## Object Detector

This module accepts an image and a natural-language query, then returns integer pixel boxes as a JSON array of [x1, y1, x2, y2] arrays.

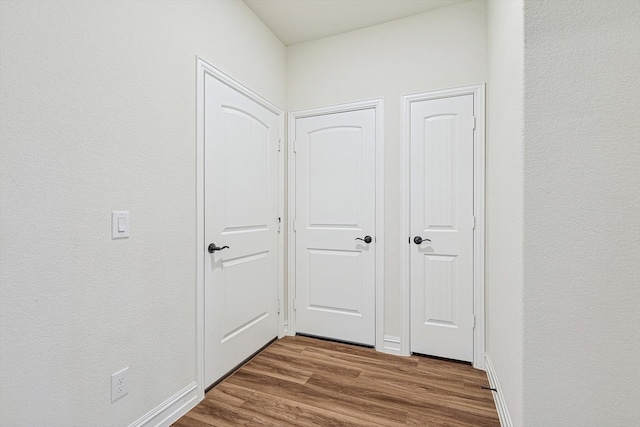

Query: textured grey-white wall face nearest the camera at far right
[[524, 0, 640, 426]]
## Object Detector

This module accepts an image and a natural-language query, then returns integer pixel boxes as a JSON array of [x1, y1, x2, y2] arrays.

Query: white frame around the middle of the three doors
[[287, 98, 384, 351]]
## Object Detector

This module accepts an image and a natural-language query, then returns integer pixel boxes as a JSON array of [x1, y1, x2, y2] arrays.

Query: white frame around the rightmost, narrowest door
[[400, 83, 485, 369]]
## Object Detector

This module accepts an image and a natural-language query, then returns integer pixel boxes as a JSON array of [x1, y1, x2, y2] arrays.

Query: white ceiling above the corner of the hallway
[[244, 0, 468, 46]]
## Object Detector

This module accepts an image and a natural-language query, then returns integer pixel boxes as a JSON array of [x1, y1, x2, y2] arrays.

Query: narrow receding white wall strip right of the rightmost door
[[486, 0, 524, 426]]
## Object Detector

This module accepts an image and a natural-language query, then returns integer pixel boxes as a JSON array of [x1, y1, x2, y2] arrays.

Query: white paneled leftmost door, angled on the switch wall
[[202, 74, 279, 386]]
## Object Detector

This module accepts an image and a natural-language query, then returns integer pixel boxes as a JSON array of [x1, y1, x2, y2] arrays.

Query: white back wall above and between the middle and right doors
[[287, 0, 487, 337]]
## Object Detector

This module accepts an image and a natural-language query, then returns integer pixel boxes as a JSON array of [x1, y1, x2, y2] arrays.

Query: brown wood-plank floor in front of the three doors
[[173, 337, 500, 427]]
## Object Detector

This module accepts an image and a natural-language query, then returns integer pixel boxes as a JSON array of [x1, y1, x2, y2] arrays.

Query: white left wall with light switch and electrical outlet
[[0, 0, 285, 426]]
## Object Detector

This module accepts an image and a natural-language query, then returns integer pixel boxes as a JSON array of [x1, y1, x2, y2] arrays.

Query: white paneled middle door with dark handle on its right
[[294, 108, 376, 345]]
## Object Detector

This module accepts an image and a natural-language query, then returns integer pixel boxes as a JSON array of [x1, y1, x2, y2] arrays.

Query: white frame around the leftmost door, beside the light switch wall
[[196, 57, 284, 400]]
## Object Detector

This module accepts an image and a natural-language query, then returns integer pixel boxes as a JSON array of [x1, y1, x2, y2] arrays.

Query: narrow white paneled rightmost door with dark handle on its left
[[410, 95, 475, 361]]
